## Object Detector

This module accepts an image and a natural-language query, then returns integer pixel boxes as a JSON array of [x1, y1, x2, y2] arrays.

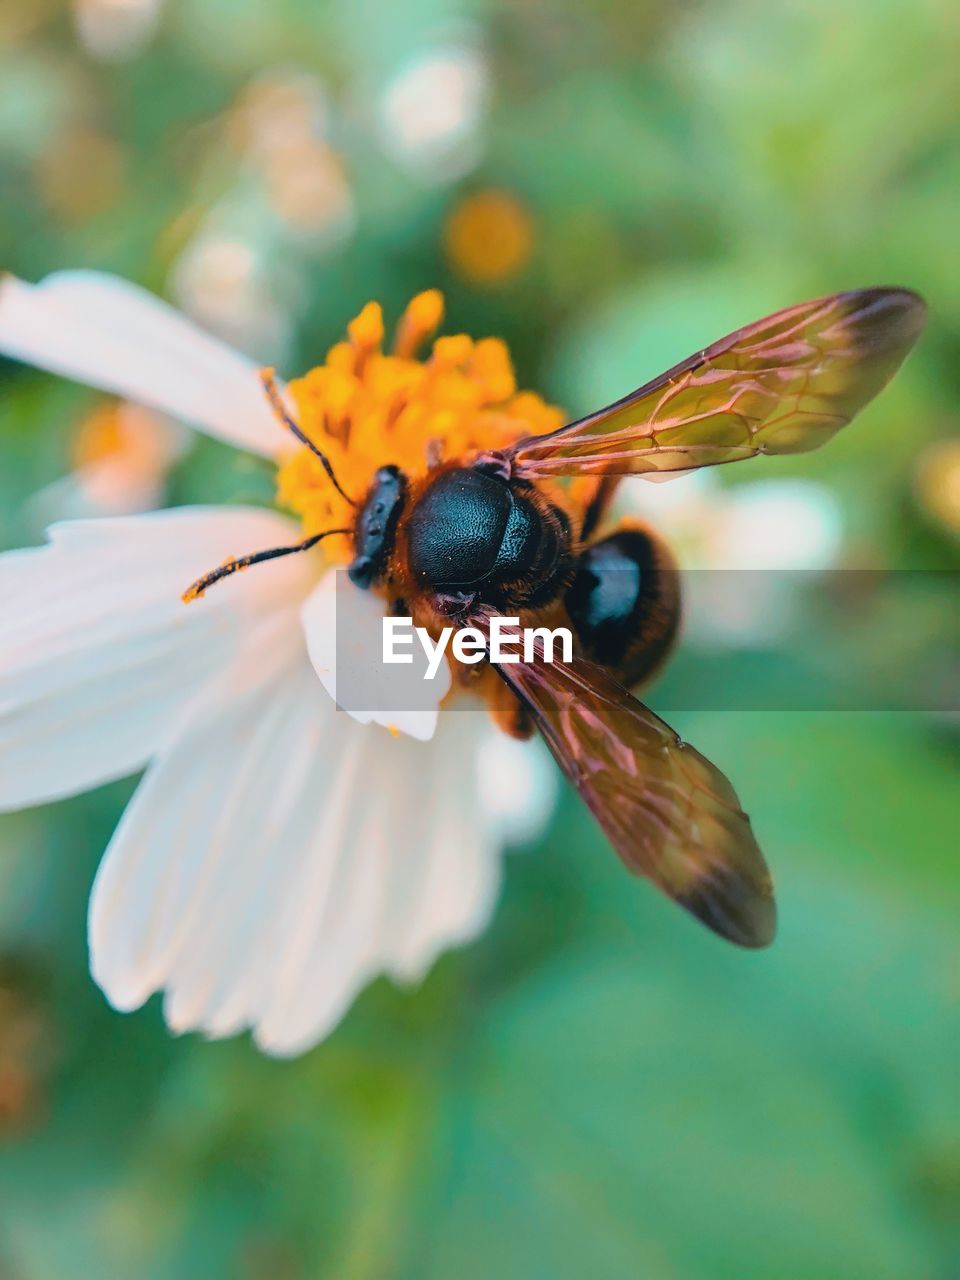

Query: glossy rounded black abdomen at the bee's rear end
[[564, 521, 680, 689]]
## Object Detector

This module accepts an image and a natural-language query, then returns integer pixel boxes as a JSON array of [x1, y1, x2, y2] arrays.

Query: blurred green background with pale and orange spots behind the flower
[[0, 0, 960, 1280]]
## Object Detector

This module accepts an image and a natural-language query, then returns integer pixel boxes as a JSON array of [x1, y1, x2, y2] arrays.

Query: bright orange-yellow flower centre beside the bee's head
[[276, 289, 563, 563]]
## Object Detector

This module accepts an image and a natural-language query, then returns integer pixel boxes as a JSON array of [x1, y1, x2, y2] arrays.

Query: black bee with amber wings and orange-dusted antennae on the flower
[[187, 288, 925, 947]]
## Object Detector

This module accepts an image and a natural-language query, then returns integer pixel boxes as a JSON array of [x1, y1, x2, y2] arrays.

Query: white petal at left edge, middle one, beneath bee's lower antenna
[[0, 507, 314, 809]]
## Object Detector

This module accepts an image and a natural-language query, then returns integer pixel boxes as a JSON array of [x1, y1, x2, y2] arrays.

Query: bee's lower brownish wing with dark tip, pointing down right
[[477, 621, 777, 947]]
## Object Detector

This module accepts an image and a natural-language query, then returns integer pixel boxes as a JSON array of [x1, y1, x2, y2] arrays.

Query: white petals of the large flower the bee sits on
[[0, 271, 553, 1055]]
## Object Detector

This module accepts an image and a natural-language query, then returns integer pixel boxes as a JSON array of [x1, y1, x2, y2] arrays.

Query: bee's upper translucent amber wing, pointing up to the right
[[504, 288, 927, 480]]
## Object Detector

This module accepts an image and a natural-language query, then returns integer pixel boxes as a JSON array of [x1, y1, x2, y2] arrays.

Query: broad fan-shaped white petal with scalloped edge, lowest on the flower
[[90, 660, 499, 1056]]
